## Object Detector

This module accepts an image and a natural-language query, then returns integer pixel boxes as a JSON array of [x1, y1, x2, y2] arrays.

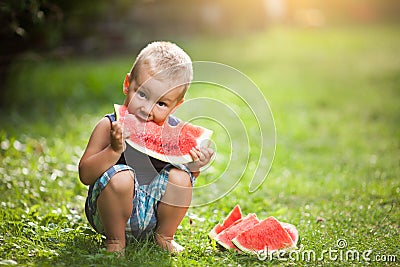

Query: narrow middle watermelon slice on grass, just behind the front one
[[215, 213, 260, 250]]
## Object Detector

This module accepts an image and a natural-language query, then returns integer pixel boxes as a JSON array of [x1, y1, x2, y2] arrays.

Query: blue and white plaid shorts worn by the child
[[85, 164, 195, 239]]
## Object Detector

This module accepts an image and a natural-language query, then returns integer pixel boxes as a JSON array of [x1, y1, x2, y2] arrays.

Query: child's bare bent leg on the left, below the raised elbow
[[97, 171, 135, 252]]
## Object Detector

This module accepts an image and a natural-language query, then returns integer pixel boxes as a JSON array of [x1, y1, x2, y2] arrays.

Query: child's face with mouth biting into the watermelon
[[125, 68, 183, 125]]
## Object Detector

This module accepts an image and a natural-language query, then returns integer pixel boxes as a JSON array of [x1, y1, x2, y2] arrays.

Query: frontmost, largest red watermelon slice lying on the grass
[[232, 216, 296, 253]]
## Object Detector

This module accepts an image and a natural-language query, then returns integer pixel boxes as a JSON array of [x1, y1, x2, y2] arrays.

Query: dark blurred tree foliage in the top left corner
[[0, 0, 136, 105]]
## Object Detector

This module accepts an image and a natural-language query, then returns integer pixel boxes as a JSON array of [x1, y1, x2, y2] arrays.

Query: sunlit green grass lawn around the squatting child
[[0, 26, 400, 266]]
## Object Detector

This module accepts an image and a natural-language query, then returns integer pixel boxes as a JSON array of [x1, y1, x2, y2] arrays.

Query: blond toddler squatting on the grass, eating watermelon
[[79, 42, 214, 253]]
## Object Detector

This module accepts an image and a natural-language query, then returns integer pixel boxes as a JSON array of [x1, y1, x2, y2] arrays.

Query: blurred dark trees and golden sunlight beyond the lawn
[[0, 0, 400, 98]]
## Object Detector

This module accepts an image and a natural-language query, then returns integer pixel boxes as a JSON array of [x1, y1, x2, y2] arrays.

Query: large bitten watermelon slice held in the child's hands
[[114, 104, 213, 164]]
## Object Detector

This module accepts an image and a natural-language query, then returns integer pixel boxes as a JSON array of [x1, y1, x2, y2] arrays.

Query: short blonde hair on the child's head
[[130, 41, 193, 90]]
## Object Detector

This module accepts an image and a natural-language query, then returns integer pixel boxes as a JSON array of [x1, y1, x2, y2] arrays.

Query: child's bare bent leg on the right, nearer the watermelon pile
[[156, 168, 192, 252]]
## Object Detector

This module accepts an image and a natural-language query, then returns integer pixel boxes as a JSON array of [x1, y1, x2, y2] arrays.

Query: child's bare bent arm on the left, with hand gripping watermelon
[[79, 118, 125, 185]]
